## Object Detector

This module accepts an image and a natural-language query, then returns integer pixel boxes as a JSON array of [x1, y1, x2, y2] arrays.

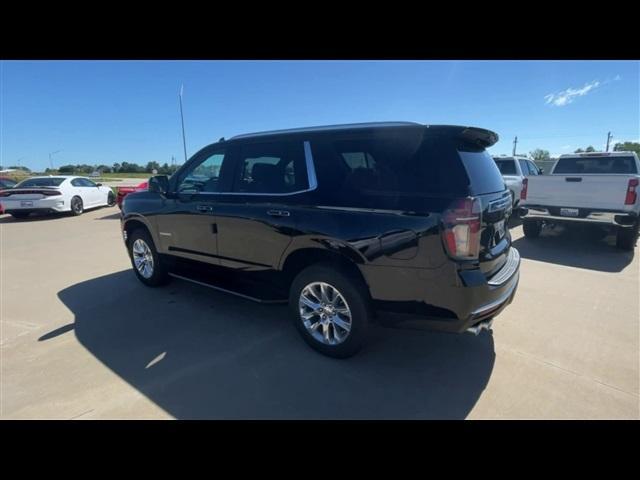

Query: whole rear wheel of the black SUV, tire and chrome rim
[[289, 264, 370, 358]]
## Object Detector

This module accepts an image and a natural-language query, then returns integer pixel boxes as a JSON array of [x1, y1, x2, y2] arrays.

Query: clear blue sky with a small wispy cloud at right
[[0, 61, 640, 171]]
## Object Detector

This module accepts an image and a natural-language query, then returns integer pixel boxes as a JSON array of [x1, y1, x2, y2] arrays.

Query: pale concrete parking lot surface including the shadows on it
[[0, 208, 640, 419]]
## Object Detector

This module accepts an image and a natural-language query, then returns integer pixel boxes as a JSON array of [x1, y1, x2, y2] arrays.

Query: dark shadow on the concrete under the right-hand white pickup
[[513, 226, 634, 272]]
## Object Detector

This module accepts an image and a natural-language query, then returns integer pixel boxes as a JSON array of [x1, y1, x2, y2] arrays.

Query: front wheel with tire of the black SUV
[[128, 228, 170, 287]]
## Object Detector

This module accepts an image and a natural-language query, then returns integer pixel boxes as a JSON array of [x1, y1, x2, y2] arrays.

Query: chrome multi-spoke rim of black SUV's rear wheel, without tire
[[298, 282, 351, 345]]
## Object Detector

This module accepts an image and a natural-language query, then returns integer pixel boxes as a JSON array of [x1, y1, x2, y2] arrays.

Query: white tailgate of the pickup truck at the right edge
[[523, 174, 638, 210]]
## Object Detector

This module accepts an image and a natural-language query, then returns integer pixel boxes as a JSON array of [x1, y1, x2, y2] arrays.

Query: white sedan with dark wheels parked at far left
[[0, 175, 116, 218]]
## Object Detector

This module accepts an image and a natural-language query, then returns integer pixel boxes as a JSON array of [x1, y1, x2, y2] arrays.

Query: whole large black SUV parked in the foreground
[[122, 122, 520, 357]]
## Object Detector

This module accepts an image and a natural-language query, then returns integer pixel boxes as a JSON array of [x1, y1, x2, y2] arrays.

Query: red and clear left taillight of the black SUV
[[442, 198, 482, 260]]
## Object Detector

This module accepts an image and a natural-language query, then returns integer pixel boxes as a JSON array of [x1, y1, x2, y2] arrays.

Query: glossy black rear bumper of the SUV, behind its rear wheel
[[364, 247, 520, 333]]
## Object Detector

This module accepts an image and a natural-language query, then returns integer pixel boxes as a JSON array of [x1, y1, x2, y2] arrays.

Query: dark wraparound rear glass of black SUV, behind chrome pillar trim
[[312, 130, 505, 205]]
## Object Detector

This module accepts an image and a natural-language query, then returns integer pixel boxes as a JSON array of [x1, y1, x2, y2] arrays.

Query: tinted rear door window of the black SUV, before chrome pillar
[[233, 142, 309, 194]]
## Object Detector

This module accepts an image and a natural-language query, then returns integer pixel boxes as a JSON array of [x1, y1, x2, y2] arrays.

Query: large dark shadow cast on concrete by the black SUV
[[56, 270, 495, 419]]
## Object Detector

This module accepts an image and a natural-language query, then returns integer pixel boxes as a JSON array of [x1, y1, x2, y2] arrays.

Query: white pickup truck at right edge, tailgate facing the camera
[[520, 152, 640, 250]]
